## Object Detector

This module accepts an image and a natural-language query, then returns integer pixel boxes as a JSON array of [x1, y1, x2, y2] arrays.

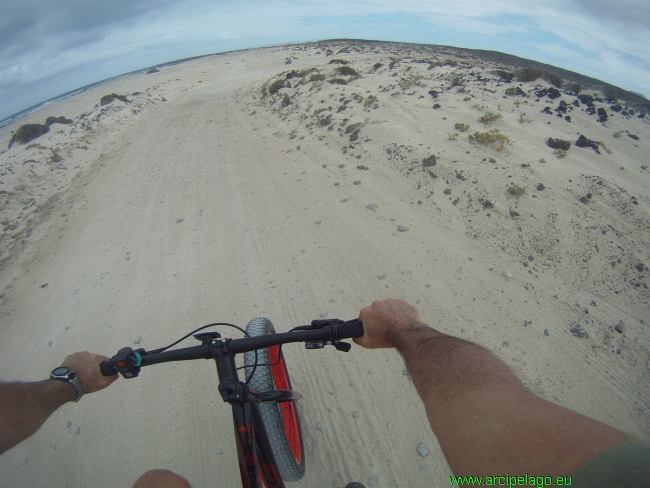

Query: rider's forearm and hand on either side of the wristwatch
[[0, 351, 118, 454]]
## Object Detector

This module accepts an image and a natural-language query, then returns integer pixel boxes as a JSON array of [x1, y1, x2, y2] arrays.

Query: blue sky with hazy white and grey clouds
[[0, 0, 650, 120]]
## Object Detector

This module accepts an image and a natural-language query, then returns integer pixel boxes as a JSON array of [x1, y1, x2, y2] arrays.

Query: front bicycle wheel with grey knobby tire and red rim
[[244, 317, 305, 481]]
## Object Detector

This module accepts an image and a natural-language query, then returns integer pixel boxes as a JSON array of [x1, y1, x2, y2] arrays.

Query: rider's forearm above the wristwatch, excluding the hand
[[0, 380, 77, 454]]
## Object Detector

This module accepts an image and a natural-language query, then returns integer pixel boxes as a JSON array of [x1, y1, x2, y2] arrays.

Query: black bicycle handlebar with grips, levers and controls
[[100, 319, 363, 378]]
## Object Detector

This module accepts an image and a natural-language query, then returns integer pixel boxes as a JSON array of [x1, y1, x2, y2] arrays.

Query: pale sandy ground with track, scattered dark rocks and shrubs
[[0, 43, 650, 487]]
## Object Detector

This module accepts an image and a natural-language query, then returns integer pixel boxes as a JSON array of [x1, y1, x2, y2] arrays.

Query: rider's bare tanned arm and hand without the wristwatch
[[355, 300, 632, 476]]
